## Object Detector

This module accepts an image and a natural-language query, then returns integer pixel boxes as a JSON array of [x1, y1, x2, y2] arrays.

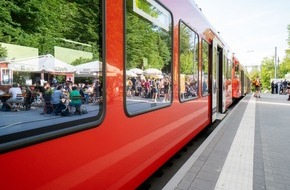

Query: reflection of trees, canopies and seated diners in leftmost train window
[[0, 0, 103, 144]]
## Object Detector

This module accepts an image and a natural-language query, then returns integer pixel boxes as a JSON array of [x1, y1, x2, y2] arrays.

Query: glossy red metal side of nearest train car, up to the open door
[[0, 0, 245, 190]]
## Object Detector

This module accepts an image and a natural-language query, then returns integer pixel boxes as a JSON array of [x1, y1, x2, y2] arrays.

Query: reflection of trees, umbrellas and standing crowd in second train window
[[124, 0, 172, 115]]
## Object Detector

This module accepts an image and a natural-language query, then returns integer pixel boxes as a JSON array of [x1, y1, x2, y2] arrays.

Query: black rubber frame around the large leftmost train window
[[0, 0, 106, 153]]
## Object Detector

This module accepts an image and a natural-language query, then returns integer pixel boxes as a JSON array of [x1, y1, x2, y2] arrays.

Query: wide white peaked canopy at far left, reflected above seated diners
[[8, 54, 76, 73]]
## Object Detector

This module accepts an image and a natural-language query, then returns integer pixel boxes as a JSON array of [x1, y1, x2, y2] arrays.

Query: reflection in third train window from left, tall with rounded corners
[[179, 22, 199, 101]]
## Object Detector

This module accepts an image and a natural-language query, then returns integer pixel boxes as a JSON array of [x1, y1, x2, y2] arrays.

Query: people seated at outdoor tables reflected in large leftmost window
[[2, 78, 102, 115]]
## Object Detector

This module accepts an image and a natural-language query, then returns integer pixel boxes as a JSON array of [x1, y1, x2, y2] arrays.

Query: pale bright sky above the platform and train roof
[[194, 0, 290, 66]]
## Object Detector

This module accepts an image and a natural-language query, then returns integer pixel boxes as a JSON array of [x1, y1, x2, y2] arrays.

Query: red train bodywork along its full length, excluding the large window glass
[[0, 0, 246, 190]]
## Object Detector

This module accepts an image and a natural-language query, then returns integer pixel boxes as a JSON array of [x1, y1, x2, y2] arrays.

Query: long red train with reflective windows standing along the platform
[[0, 0, 248, 190]]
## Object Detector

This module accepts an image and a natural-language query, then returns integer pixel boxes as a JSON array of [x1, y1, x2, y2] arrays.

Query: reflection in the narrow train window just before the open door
[[201, 40, 210, 96]]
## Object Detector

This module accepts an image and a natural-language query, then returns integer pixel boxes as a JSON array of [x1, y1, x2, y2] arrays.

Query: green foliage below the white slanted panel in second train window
[[126, 12, 171, 69]]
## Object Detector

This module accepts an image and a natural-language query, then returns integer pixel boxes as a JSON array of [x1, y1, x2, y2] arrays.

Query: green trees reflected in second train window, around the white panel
[[126, 0, 171, 71]]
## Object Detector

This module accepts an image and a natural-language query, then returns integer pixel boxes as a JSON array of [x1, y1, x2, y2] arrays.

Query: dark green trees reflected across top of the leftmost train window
[[0, 0, 102, 58]]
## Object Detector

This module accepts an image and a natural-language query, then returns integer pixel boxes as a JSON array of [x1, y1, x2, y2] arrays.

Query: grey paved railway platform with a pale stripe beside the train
[[163, 93, 290, 190]]
